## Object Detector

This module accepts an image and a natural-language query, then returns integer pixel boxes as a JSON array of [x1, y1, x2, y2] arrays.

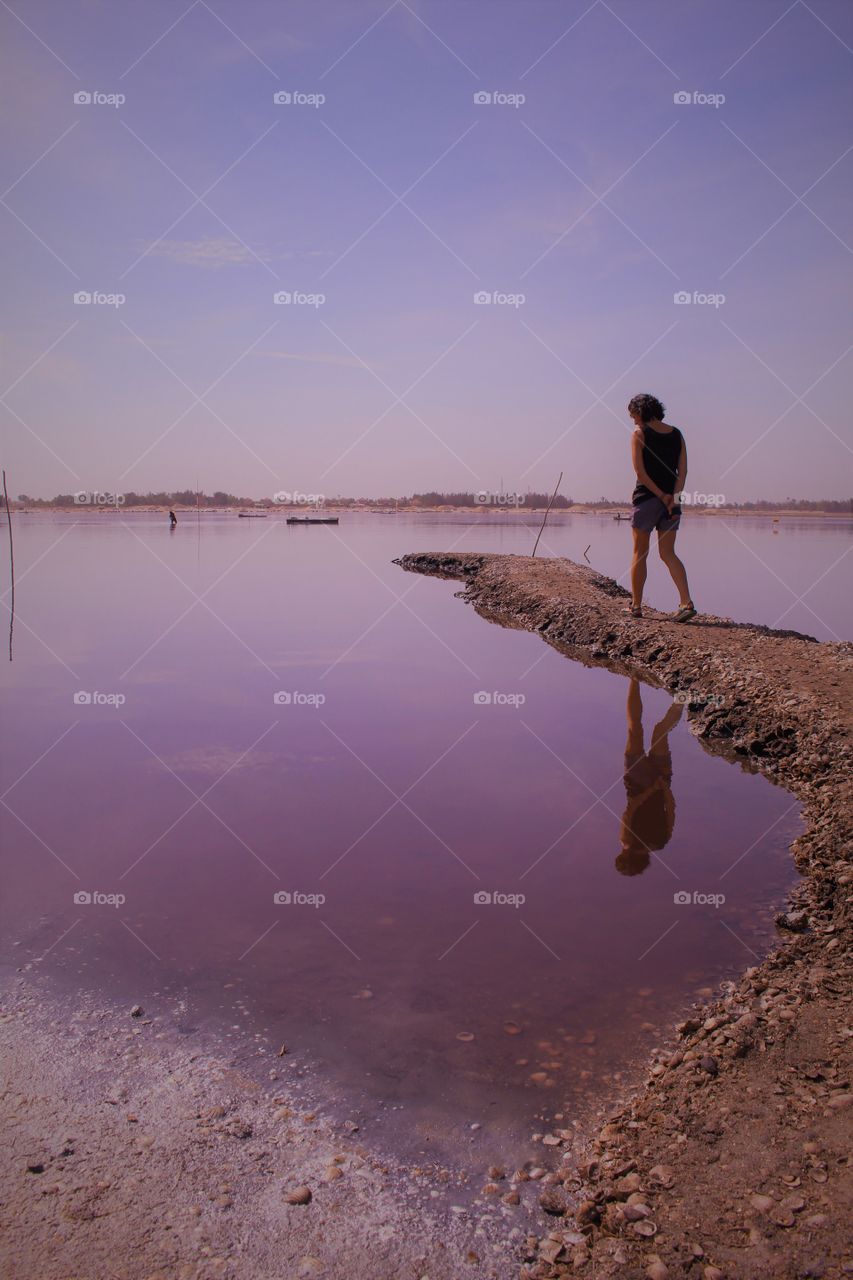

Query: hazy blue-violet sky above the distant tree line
[[0, 0, 853, 502]]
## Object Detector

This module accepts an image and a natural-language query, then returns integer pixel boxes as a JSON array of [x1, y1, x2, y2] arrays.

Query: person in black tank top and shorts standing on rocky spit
[[625, 394, 695, 622]]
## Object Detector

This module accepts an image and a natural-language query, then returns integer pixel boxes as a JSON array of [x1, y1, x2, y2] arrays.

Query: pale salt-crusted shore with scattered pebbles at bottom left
[[0, 975, 543, 1280]]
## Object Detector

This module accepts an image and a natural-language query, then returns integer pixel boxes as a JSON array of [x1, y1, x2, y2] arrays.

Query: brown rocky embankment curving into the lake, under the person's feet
[[397, 553, 853, 1280]]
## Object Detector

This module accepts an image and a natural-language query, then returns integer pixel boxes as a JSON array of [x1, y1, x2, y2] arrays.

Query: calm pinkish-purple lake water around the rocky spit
[[0, 515, 829, 1164]]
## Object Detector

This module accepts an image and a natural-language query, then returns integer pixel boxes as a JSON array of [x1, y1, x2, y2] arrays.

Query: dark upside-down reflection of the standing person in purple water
[[616, 680, 681, 876]]
